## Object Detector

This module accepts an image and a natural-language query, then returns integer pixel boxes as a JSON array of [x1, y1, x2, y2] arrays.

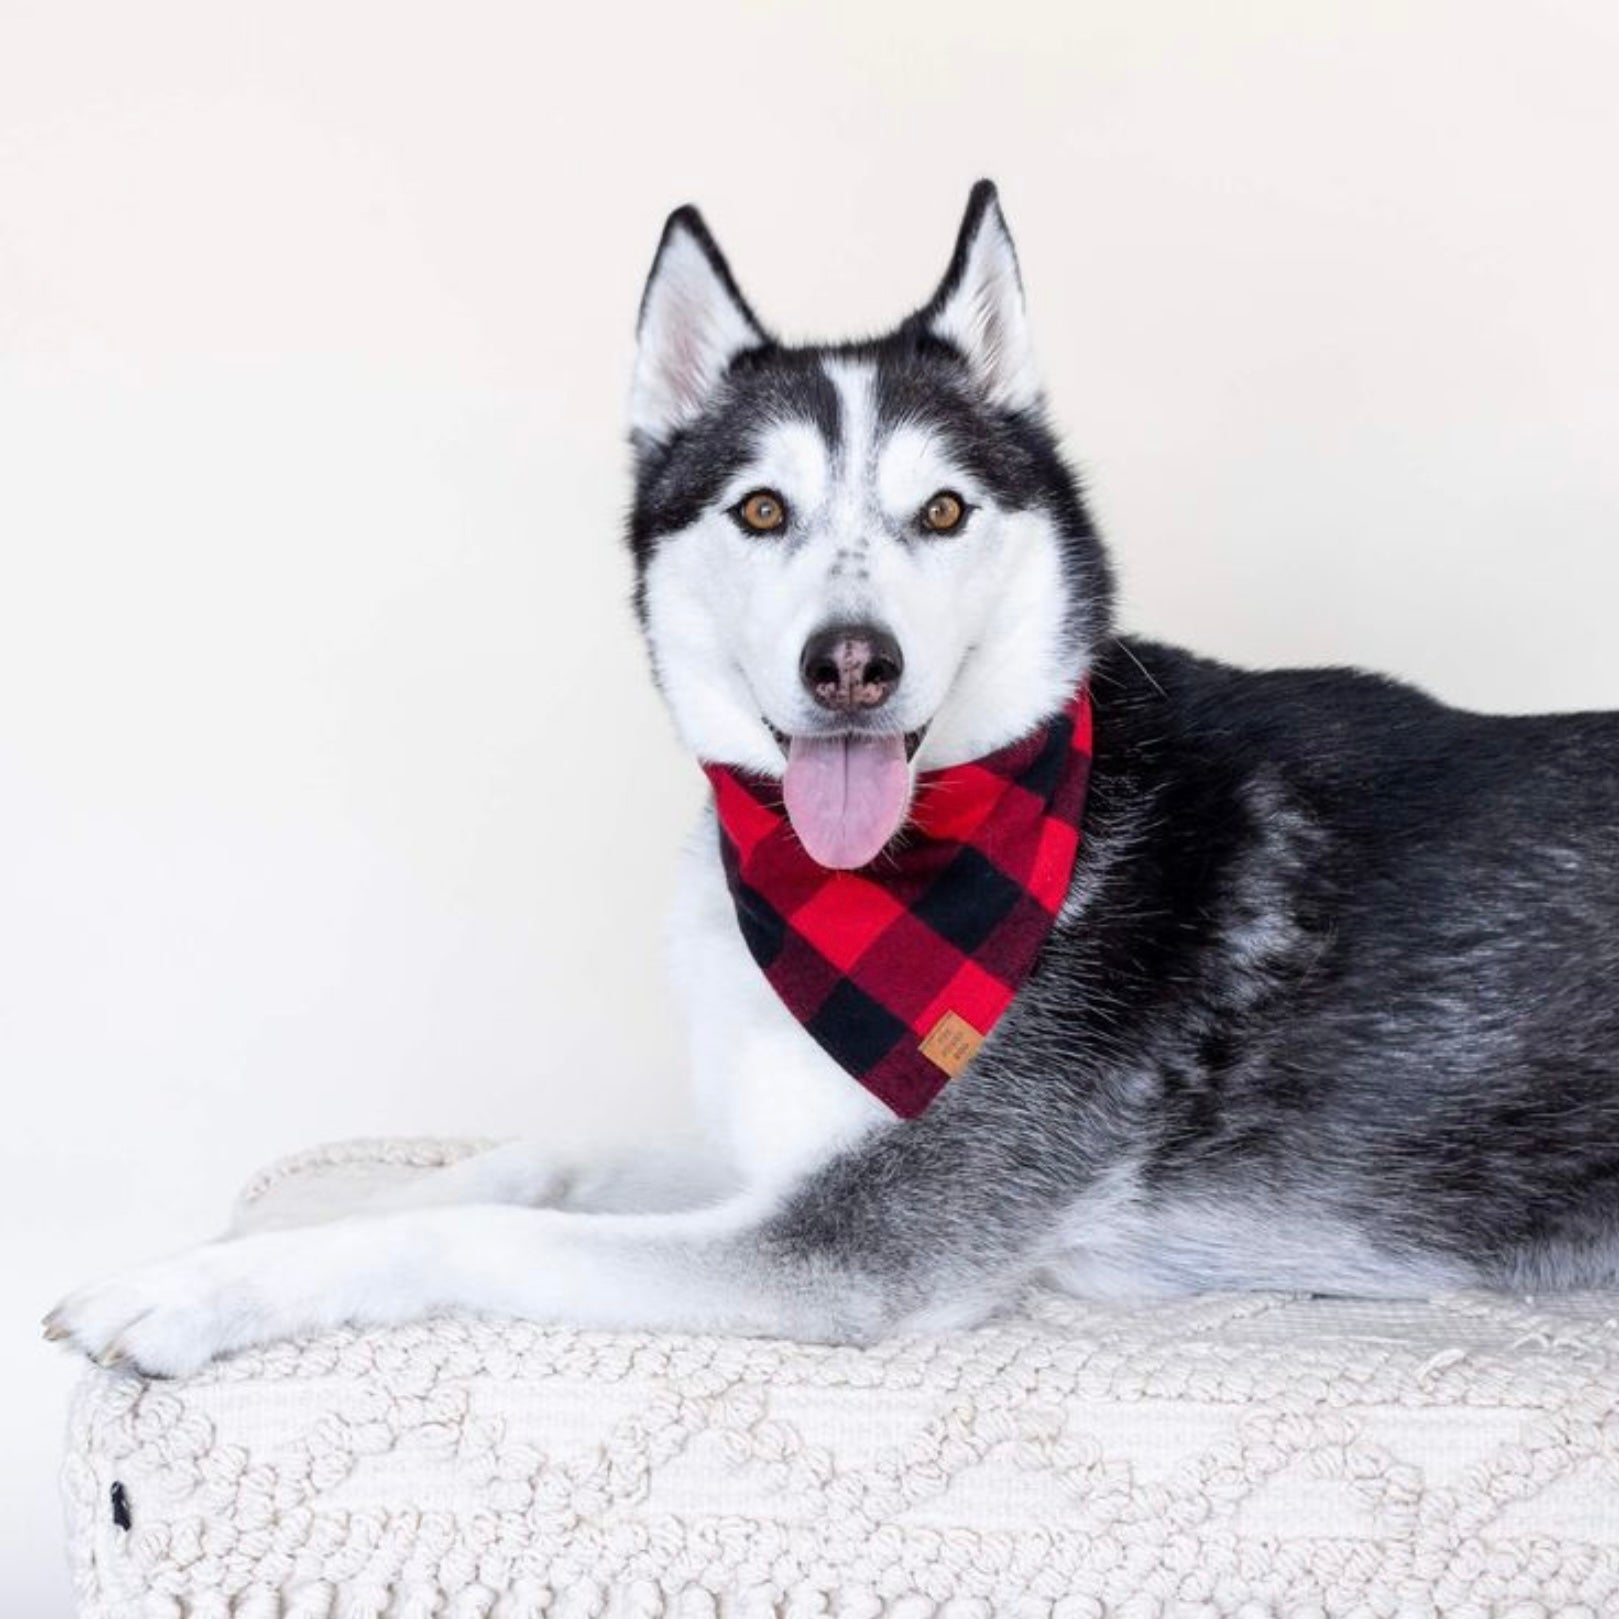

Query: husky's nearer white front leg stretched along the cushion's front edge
[[47, 1198, 881, 1376]]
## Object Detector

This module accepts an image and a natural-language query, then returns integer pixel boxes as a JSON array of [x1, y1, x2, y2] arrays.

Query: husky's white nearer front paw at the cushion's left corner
[[45, 1243, 275, 1378]]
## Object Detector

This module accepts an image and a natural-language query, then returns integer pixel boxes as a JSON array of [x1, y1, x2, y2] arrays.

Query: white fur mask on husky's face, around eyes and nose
[[644, 359, 1078, 772]]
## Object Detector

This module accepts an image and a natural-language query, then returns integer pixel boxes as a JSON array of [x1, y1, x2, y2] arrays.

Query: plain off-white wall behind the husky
[[0, 0, 1619, 1619]]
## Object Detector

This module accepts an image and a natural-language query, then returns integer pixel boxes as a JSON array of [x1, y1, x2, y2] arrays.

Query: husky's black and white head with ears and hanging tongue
[[630, 181, 1111, 866]]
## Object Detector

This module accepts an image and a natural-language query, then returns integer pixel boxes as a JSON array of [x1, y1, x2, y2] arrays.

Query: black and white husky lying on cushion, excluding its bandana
[[47, 183, 1619, 1375]]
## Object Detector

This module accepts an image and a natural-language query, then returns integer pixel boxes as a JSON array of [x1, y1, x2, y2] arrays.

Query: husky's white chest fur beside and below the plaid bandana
[[670, 811, 894, 1185]]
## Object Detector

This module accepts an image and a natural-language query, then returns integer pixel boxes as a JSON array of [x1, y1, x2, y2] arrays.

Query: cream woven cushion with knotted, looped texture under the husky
[[65, 1143, 1619, 1619]]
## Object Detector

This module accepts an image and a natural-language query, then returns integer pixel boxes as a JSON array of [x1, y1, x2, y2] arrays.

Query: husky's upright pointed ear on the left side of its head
[[630, 207, 769, 447]]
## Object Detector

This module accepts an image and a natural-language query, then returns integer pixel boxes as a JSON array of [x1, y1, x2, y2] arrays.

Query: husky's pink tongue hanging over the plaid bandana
[[782, 737, 910, 871]]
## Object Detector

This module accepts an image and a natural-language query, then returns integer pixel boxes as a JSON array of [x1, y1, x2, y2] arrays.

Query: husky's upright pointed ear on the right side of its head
[[921, 180, 1039, 410]]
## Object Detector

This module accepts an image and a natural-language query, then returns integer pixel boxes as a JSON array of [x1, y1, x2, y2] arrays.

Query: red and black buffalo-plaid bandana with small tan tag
[[704, 686, 1091, 1119]]
